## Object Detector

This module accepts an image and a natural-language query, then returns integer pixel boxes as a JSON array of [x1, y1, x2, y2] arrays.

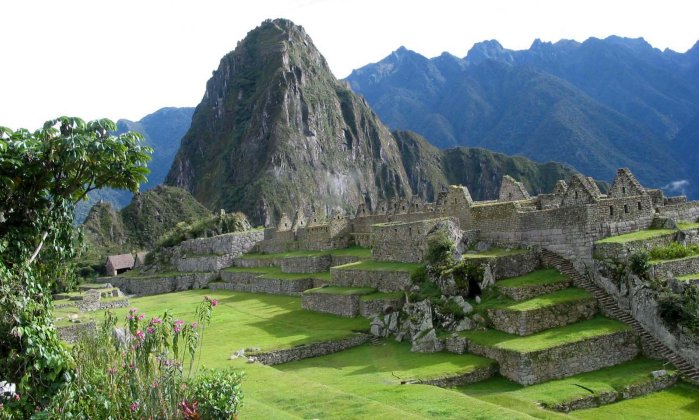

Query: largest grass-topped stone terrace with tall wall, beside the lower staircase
[[460, 317, 639, 385]]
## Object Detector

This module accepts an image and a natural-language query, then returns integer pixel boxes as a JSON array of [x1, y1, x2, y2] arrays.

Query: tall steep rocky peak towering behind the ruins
[[167, 19, 411, 224]]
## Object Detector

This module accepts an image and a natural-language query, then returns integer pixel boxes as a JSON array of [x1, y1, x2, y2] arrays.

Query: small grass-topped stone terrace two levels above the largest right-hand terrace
[[495, 269, 571, 301]]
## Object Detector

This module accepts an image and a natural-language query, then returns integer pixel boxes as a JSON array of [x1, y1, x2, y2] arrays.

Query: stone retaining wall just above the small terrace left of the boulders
[[330, 267, 411, 292]]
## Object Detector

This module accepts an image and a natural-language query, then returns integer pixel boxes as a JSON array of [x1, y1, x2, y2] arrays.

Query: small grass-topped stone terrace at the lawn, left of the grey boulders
[[301, 286, 376, 318]]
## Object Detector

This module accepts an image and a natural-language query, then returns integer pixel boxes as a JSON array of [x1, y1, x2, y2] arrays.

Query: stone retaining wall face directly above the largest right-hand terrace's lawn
[[488, 297, 597, 335]]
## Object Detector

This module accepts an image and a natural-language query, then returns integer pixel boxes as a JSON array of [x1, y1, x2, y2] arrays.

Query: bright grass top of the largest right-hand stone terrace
[[461, 317, 630, 353]]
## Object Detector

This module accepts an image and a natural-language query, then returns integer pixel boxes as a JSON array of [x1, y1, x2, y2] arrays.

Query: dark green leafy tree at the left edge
[[0, 117, 152, 414]]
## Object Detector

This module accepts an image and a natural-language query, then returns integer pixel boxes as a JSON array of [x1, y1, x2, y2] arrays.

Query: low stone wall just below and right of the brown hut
[[109, 273, 218, 296]]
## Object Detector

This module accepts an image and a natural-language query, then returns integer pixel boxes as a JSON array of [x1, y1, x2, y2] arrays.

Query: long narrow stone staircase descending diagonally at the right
[[542, 250, 699, 384]]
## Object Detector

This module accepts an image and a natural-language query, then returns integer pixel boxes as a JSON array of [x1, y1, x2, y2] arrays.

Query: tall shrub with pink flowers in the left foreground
[[43, 296, 241, 419]]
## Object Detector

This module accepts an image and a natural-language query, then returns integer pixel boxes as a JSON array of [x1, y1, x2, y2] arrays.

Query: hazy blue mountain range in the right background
[[347, 37, 699, 195]]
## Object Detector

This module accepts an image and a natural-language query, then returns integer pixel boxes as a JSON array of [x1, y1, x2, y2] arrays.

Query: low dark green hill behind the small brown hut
[[81, 185, 212, 266]]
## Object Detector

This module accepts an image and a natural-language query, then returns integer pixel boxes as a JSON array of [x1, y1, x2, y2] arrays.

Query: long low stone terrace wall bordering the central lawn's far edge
[[209, 271, 314, 296]]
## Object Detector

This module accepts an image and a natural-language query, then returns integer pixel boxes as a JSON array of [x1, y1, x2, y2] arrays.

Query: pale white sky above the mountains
[[0, 0, 699, 129]]
